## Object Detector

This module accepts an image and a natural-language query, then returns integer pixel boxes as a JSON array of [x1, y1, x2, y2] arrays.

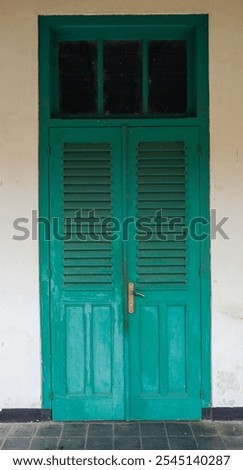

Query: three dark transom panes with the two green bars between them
[[58, 40, 189, 117]]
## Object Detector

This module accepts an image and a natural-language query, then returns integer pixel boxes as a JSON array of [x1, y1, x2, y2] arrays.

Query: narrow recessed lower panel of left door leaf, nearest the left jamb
[[65, 306, 86, 394]]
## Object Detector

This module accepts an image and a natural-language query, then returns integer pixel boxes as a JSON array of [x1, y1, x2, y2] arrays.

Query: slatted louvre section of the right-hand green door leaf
[[137, 142, 187, 289]]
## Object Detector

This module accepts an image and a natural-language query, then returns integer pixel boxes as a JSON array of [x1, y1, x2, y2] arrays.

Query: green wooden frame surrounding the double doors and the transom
[[39, 15, 211, 409]]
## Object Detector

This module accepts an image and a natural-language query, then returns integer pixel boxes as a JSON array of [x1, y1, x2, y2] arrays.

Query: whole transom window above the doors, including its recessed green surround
[[44, 15, 205, 122]]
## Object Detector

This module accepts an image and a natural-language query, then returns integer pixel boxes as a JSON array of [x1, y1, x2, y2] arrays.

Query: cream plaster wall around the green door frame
[[0, 0, 243, 408]]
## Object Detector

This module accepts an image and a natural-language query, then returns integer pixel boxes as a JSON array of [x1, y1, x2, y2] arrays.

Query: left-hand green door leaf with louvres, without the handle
[[51, 129, 124, 420]]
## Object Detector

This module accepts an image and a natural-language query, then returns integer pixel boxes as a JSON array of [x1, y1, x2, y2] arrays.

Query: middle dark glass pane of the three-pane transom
[[104, 41, 142, 114]]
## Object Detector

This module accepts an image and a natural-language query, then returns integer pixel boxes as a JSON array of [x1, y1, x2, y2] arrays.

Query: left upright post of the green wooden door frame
[[39, 17, 52, 409]]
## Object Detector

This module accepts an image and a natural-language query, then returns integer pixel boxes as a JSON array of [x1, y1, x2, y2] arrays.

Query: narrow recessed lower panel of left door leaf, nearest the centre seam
[[91, 305, 115, 395]]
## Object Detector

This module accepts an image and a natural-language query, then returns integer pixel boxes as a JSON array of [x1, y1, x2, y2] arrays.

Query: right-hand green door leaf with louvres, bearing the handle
[[127, 128, 201, 419]]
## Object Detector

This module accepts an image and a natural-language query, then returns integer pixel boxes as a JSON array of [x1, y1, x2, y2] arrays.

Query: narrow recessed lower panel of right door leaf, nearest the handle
[[140, 307, 160, 395]]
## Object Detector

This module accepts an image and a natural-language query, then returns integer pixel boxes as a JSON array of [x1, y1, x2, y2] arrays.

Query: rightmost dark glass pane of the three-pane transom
[[148, 41, 187, 113]]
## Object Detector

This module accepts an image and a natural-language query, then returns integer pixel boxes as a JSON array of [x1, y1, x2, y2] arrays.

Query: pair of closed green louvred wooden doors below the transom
[[50, 124, 201, 420]]
